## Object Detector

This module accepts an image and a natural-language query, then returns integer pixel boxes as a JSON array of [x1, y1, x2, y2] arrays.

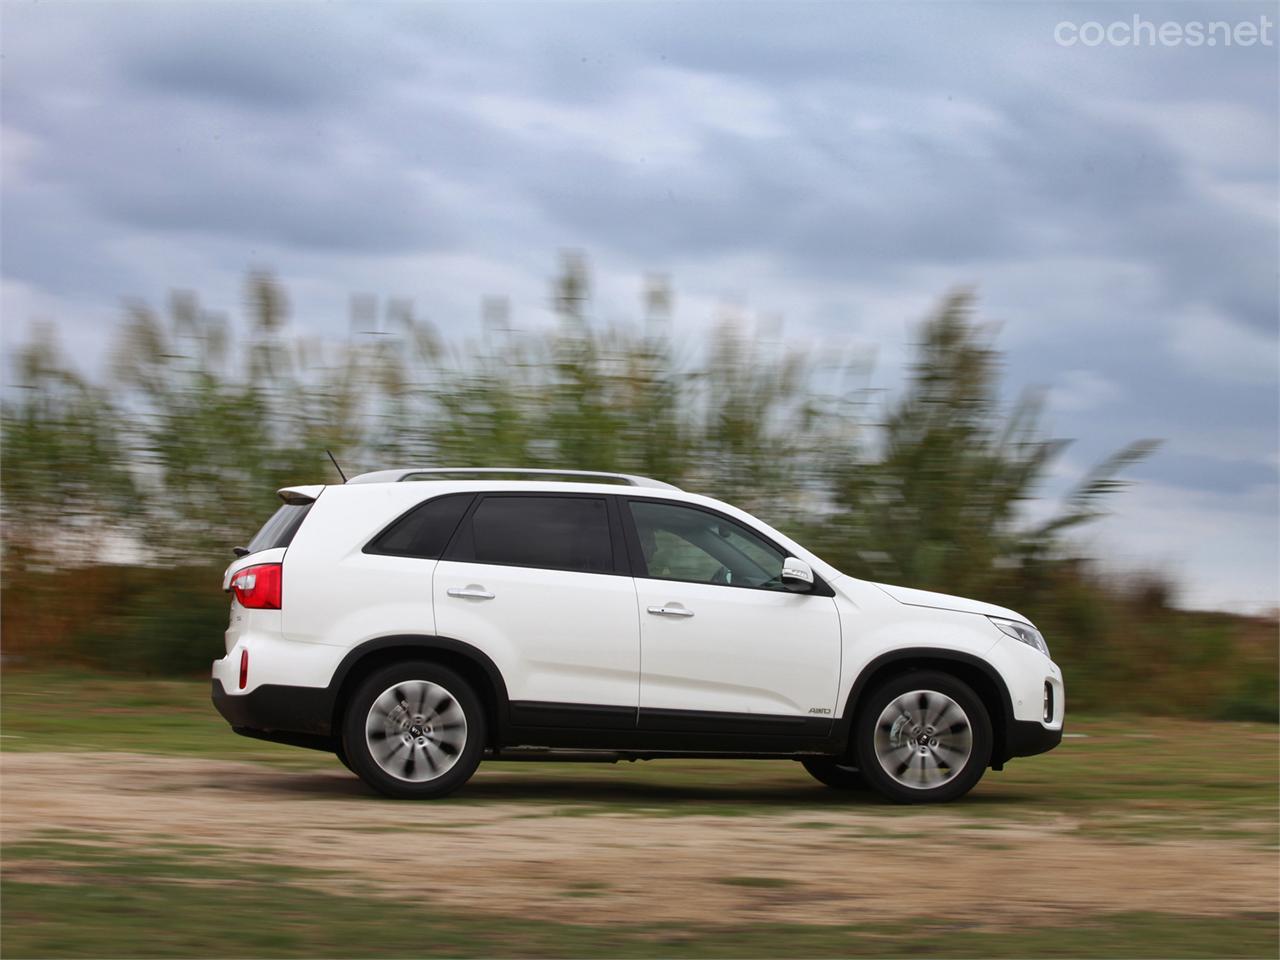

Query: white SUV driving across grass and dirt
[[212, 468, 1064, 803]]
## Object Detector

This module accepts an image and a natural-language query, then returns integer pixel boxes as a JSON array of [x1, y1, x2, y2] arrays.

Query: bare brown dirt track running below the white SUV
[[0, 753, 1277, 927]]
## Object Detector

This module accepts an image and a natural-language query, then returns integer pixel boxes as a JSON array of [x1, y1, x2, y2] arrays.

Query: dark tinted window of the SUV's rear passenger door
[[449, 497, 613, 573]]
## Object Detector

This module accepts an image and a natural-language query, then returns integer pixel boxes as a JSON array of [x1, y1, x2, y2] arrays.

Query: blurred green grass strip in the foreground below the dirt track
[[0, 841, 1280, 957]]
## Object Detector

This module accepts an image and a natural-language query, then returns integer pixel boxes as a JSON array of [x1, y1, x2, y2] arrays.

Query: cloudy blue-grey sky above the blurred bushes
[[0, 1, 1280, 611]]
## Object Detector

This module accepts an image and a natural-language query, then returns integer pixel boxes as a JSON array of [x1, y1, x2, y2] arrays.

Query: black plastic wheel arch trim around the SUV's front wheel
[[837, 646, 1014, 771]]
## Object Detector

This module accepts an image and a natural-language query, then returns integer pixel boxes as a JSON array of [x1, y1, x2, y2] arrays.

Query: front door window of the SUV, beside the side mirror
[[630, 500, 786, 590]]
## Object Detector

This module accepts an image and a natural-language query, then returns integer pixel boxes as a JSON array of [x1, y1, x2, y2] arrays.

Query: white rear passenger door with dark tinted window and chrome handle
[[433, 493, 640, 728]]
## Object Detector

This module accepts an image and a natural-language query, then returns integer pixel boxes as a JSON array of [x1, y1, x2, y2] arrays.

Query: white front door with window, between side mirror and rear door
[[623, 499, 840, 735]]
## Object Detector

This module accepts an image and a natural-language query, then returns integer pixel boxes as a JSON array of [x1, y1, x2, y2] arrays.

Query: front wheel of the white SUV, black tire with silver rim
[[854, 671, 992, 804]]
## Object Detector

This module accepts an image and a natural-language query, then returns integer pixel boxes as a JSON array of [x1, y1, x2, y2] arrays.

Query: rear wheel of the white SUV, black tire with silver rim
[[342, 660, 486, 800]]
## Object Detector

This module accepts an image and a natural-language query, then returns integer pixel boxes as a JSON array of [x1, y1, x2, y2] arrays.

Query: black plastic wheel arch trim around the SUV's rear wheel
[[330, 634, 509, 746]]
